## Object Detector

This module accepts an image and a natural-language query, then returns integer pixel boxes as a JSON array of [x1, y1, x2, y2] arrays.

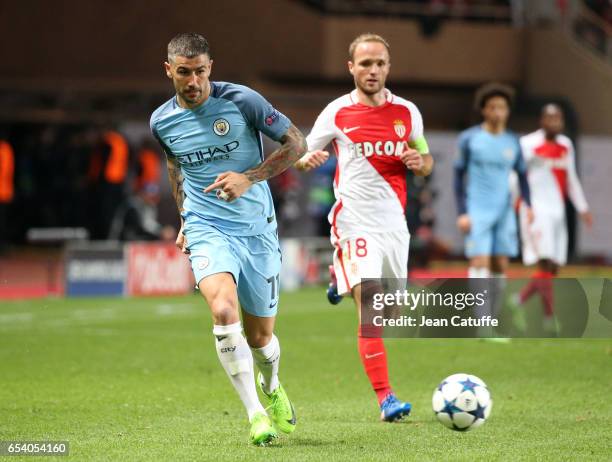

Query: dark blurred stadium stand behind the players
[[0, 0, 612, 268]]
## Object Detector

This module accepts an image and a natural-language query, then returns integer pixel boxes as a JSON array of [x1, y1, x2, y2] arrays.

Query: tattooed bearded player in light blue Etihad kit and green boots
[[151, 33, 306, 445]]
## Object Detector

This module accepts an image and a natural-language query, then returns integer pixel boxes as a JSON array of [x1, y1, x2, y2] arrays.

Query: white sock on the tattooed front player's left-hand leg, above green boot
[[213, 322, 265, 421]]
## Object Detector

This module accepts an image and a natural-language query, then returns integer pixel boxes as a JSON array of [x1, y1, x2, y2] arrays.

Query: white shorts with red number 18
[[331, 230, 410, 295]]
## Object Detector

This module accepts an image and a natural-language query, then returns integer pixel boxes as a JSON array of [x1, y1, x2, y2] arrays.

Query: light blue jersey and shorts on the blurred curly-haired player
[[455, 125, 528, 257]]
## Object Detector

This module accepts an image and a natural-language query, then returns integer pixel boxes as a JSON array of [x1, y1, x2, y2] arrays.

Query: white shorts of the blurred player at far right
[[519, 203, 568, 266]]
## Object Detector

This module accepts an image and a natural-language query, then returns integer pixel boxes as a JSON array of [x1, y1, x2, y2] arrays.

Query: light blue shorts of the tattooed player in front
[[183, 219, 281, 317]]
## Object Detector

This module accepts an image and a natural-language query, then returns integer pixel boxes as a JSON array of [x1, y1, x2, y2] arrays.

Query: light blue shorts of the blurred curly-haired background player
[[465, 207, 518, 258]]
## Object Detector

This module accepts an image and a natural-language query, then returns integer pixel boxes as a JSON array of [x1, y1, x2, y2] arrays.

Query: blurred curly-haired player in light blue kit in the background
[[455, 83, 533, 336]]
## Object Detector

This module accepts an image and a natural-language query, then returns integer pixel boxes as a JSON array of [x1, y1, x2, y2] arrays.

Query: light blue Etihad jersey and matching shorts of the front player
[[151, 82, 291, 317]]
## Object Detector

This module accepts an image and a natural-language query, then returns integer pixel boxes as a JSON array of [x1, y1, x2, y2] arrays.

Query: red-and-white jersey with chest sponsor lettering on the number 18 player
[[306, 90, 423, 237]]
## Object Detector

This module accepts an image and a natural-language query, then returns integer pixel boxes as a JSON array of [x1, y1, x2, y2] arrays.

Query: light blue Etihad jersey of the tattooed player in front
[[151, 82, 291, 236]]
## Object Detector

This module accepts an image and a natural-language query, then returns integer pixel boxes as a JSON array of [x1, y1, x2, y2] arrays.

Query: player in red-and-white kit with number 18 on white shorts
[[296, 34, 433, 421]]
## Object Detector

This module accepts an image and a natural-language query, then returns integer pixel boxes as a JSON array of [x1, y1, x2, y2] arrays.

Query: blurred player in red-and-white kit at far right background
[[513, 104, 593, 333]]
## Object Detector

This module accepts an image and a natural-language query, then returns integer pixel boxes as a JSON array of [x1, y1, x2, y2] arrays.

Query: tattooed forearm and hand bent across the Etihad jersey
[[204, 125, 307, 201]]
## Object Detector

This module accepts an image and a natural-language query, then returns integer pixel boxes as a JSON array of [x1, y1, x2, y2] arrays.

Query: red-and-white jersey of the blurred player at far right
[[521, 130, 588, 216]]
